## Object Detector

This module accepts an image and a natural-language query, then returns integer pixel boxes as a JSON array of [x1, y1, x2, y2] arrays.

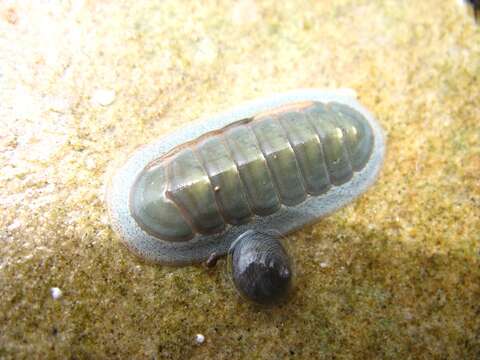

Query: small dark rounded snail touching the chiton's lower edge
[[229, 230, 293, 305]]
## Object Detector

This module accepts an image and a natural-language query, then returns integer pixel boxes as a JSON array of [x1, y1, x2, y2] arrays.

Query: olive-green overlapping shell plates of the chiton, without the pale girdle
[[130, 102, 373, 241]]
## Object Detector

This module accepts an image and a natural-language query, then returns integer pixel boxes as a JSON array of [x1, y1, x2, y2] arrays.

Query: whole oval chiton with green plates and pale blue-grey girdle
[[107, 90, 385, 265]]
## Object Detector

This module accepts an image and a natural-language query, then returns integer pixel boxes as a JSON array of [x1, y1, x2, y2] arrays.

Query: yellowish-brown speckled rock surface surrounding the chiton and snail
[[0, 0, 480, 359]]
